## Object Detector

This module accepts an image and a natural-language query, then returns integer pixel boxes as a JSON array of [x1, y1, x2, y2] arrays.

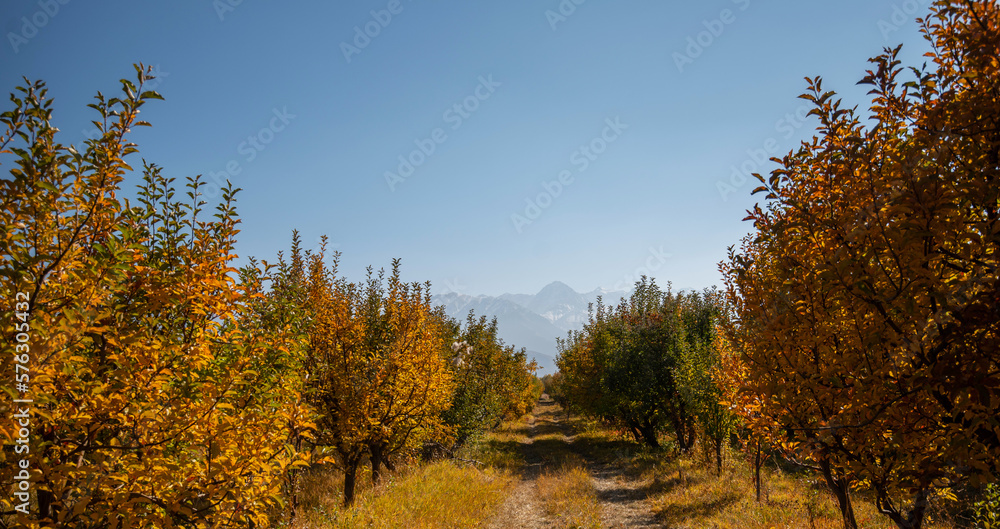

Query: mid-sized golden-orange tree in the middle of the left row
[[292, 245, 452, 505]]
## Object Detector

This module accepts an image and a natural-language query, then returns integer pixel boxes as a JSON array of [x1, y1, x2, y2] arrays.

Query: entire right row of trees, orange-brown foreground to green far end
[[551, 0, 1000, 529]]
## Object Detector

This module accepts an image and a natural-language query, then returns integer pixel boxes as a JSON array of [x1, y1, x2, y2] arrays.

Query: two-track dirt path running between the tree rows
[[489, 396, 662, 529]]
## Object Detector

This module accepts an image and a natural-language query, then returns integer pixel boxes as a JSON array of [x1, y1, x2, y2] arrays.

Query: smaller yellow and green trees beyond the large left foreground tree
[[268, 239, 540, 504]]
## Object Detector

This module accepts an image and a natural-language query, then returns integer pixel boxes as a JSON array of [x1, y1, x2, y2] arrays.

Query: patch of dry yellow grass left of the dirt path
[[293, 461, 513, 529]]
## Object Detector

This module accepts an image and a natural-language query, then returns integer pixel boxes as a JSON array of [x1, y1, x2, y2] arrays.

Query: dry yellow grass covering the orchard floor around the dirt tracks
[[284, 400, 954, 529]]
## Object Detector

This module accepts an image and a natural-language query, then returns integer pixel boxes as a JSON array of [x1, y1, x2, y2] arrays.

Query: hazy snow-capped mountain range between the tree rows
[[432, 281, 628, 375]]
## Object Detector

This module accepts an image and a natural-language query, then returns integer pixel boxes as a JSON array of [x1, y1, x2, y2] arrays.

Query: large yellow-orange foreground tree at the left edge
[[0, 66, 309, 528]]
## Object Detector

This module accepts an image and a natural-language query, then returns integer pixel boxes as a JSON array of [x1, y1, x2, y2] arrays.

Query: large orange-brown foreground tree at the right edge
[[723, 1, 1000, 528]]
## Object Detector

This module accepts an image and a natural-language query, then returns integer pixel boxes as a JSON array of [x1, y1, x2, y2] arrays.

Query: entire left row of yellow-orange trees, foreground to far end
[[0, 66, 536, 528]]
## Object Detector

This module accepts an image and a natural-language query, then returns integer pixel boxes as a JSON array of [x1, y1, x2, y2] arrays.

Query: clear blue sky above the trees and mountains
[[0, 0, 930, 295]]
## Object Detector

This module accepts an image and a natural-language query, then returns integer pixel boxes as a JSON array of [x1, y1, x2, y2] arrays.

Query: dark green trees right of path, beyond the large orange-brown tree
[[557, 278, 735, 467]]
